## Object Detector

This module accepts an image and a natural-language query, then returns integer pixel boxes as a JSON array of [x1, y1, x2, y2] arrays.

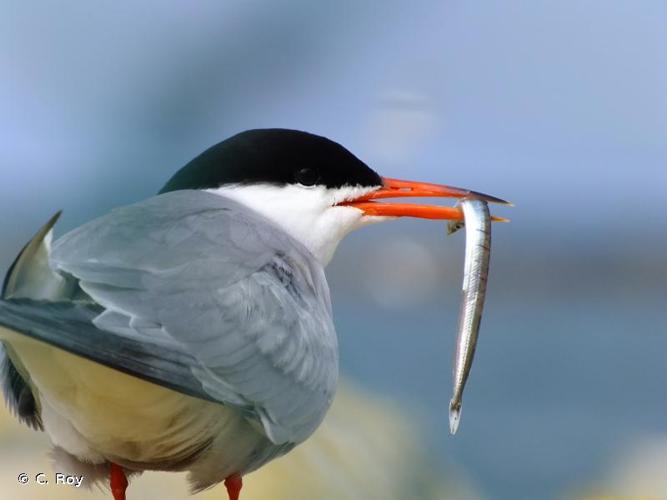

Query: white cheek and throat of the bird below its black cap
[[207, 184, 382, 266]]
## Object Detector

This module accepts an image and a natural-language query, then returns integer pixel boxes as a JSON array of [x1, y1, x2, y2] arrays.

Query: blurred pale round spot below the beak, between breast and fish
[[363, 239, 441, 309]]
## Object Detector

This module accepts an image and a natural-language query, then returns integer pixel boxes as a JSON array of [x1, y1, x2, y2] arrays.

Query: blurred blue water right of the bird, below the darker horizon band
[[334, 268, 667, 500]]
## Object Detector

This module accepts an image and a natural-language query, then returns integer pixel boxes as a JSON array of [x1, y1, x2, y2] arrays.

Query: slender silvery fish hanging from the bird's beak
[[448, 198, 492, 435]]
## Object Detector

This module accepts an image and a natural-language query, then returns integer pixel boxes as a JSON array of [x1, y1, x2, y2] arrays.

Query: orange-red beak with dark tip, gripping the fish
[[341, 177, 510, 222]]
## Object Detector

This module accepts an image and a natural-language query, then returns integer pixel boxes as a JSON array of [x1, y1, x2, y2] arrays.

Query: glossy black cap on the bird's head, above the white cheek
[[160, 128, 382, 193]]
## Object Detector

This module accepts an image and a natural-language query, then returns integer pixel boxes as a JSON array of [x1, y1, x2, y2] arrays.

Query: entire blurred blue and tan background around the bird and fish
[[0, 0, 667, 500]]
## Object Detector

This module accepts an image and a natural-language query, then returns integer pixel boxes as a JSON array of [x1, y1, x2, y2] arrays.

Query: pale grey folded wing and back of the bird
[[51, 191, 338, 444]]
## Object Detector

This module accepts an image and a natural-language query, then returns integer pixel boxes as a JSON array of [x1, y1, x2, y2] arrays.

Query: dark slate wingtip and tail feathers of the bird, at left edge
[[0, 213, 214, 430]]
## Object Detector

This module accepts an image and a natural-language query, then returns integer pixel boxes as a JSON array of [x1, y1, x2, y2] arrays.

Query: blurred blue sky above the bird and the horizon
[[0, 0, 667, 236]]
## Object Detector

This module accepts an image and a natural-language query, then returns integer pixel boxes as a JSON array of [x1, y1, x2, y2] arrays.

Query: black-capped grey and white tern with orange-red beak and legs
[[0, 128, 503, 500]]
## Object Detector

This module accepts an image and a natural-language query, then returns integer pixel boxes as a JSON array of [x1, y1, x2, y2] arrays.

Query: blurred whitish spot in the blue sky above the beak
[[368, 91, 435, 164]]
